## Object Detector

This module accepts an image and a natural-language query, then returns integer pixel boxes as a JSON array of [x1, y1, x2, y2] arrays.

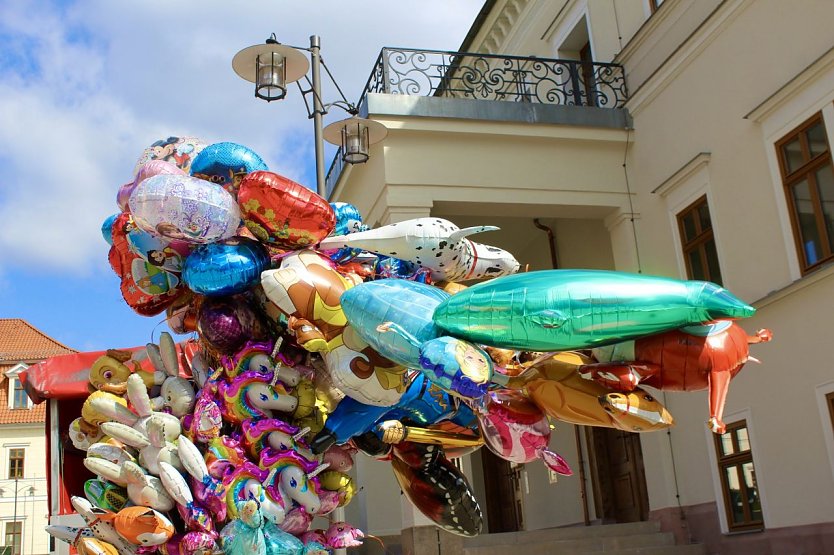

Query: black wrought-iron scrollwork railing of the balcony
[[326, 48, 627, 198]]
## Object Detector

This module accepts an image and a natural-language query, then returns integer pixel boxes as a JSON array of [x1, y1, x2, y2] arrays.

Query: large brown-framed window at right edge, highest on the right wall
[[776, 113, 834, 274]]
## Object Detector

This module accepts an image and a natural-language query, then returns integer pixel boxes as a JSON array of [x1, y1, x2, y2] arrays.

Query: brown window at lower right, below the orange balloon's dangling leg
[[715, 420, 764, 532]]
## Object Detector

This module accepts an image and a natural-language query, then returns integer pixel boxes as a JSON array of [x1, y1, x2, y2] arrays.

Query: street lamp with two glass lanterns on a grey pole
[[232, 33, 388, 197]]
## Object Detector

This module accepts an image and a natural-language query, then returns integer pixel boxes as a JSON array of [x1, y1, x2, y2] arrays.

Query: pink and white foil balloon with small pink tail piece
[[477, 390, 573, 476]]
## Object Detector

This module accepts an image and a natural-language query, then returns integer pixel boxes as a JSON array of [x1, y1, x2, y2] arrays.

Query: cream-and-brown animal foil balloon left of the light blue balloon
[[261, 251, 405, 406]]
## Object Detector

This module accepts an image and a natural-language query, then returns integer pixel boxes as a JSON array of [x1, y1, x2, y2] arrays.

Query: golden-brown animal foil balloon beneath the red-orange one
[[507, 352, 674, 432]]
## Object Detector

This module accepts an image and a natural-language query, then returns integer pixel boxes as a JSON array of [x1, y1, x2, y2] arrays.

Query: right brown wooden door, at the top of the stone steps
[[585, 427, 649, 524]]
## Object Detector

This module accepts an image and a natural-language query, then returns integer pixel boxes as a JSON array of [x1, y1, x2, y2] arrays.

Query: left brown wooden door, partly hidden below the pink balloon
[[480, 449, 524, 534]]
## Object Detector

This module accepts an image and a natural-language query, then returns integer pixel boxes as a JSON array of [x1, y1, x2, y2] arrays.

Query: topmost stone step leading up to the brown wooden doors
[[464, 520, 660, 548]]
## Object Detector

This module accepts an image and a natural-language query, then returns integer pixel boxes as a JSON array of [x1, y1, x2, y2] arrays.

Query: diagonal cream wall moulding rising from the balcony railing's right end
[[625, 0, 751, 115]]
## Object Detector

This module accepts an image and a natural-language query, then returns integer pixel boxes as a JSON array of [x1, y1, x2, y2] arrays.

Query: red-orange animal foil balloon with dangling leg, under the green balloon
[[580, 320, 772, 434]]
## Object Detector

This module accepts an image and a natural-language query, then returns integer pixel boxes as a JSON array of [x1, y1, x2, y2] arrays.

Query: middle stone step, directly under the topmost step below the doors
[[464, 532, 675, 555]]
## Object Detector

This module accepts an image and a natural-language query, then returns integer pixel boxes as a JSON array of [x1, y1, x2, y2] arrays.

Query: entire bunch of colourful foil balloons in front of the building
[[50, 137, 770, 555]]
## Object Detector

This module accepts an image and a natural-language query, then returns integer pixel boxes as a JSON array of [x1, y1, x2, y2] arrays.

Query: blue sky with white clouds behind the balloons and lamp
[[0, 0, 483, 351]]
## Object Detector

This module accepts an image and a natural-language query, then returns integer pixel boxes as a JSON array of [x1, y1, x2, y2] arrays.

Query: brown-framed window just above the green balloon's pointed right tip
[[678, 195, 722, 285]]
